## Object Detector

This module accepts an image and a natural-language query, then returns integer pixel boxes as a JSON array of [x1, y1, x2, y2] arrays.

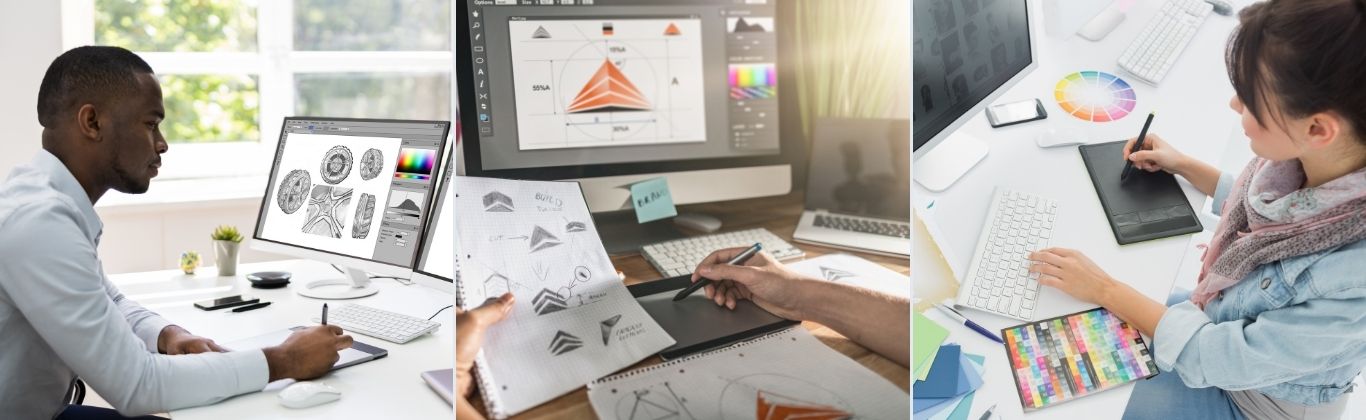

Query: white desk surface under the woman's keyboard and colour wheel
[[912, 1, 1247, 419]]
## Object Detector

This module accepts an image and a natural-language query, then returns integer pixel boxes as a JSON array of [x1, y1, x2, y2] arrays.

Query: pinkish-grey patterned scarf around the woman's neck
[[1191, 159, 1366, 308]]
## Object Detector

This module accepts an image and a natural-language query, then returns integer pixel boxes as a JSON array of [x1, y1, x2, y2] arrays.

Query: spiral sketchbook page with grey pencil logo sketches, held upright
[[455, 176, 673, 417]]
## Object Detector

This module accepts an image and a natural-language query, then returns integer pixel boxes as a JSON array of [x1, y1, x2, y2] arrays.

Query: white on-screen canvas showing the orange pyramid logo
[[508, 18, 706, 150]]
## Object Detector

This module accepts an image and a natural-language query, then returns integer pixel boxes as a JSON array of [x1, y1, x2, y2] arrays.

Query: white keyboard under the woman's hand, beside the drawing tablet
[[956, 187, 1057, 320]]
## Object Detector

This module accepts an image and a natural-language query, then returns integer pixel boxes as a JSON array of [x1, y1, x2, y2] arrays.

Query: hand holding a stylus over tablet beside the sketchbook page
[[693, 248, 810, 320]]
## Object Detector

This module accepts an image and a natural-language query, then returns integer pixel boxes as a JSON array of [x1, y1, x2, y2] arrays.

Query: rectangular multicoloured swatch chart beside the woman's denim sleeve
[[1001, 308, 1157, 412]]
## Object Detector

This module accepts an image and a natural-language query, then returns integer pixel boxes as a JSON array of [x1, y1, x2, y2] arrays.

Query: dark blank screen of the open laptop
[[806, 119, 911, 222]]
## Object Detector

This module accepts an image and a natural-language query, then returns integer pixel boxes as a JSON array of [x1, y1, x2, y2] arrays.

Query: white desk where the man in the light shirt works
[[111, 260, 455, 420]]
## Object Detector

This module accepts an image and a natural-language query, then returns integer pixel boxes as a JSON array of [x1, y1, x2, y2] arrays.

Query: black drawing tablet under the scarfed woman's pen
[[1078, 141, 1203, 245]]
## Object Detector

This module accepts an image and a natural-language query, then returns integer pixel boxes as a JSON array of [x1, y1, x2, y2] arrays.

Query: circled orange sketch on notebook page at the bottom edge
[[717, 373, 854, 420]]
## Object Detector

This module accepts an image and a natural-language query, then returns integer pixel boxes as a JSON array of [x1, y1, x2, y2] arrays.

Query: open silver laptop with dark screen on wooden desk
[[792, 118, 911, 257]]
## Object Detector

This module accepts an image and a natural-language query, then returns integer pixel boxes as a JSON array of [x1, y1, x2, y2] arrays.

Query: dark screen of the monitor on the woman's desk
[[911, 0, 1034, 151]]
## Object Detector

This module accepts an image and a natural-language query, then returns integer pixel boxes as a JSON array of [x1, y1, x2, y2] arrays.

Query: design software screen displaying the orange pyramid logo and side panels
[[462, 0, 779, 170]]
